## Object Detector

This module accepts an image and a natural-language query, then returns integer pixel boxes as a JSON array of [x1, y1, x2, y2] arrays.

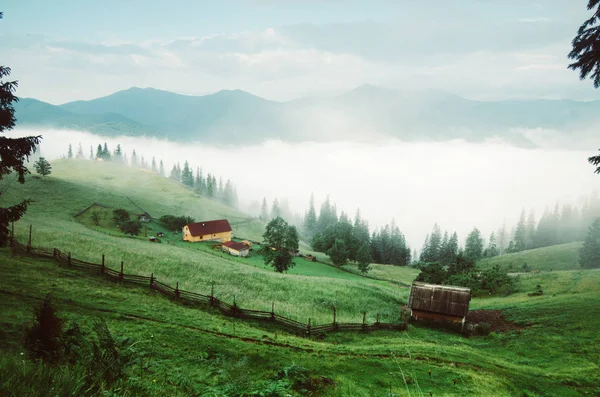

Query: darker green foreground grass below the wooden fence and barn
[[0, 250, 600, 396]]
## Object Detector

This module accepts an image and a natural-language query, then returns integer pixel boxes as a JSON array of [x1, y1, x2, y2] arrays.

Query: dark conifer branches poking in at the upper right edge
[[569, 0, 600, 174]]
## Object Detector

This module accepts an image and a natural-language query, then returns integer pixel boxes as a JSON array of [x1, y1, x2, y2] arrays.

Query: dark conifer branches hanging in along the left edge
[[0, 12, 42, 246]]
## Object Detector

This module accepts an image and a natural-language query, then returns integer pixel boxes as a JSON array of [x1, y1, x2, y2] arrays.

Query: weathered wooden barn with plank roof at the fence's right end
[[408, 282, 471, 324]]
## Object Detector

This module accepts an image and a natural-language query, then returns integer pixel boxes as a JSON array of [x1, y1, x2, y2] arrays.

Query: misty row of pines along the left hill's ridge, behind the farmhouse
[[67, 142, 239, 208]]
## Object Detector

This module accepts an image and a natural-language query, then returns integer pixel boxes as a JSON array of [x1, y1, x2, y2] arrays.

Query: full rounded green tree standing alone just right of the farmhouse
[[258, 217, 298, 273]]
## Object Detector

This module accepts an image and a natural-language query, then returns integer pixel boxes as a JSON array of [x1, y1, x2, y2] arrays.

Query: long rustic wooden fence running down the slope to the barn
[[10, 235, 407, 337]]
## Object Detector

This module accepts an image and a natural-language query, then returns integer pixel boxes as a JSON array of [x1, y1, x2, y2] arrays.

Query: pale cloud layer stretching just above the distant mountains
[[0, 18, 594, 103]]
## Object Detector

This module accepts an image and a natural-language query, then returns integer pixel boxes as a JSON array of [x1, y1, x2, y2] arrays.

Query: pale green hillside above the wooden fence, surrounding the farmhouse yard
[[3, 160, 408, 323]]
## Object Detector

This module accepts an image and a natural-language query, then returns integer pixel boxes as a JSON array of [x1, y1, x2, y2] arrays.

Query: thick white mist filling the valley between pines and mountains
[[7, 129, 600, 249]]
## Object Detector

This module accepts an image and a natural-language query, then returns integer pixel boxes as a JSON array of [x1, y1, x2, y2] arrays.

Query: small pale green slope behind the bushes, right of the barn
[[478, 243, 581, 272]]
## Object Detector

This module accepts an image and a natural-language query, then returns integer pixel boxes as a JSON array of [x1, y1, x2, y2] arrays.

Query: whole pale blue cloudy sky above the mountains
[[0, 0, 600, 104]]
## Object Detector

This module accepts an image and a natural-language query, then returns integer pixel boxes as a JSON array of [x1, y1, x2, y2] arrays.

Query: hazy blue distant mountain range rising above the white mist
[[15, 85, 600, 148]]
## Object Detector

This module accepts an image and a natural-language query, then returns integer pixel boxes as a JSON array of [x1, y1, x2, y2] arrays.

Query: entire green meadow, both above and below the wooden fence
[[0, 160, 600, 397]]
